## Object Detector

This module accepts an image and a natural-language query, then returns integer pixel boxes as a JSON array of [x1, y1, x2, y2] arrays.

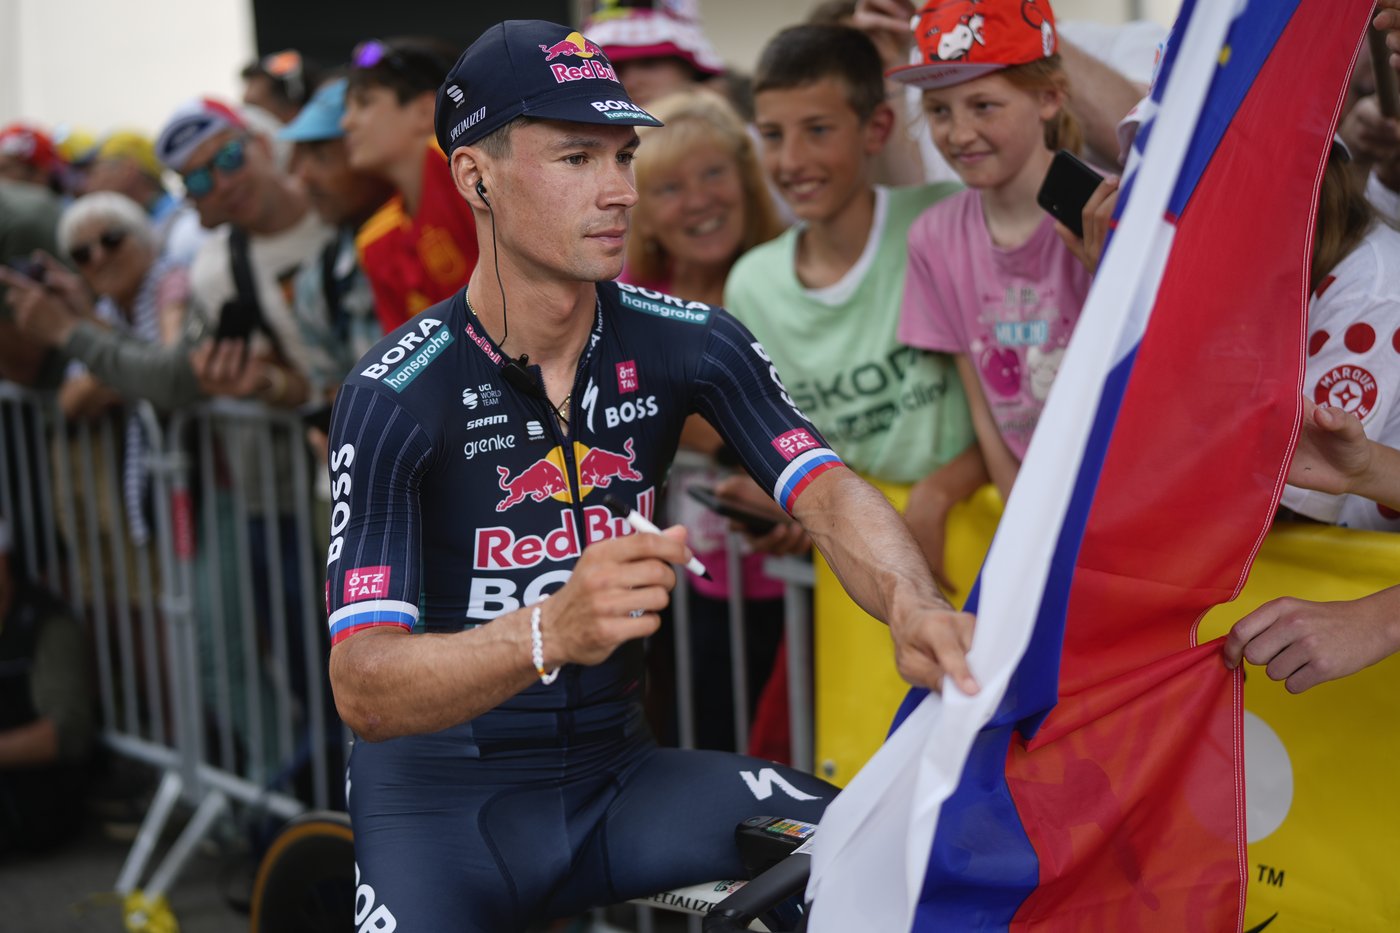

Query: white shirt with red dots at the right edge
[[1282, 223, 1400, 531]]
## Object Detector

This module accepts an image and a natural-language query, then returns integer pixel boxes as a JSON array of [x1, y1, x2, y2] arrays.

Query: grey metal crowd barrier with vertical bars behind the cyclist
[[0, 381, 812, 932]]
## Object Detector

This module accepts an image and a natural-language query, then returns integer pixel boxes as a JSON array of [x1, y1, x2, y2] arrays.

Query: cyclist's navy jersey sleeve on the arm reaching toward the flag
[[696, 308, 843, 513]]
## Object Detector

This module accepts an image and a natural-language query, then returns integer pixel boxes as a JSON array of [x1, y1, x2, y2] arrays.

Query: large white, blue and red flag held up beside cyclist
[[808, 0, 1371, 933]]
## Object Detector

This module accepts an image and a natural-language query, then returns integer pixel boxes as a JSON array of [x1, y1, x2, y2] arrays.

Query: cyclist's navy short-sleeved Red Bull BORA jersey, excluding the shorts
[[326, 283, 840, 738]]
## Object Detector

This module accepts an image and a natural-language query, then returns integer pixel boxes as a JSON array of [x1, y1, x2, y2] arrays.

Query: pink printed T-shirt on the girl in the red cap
[[899, 191, 1091, 458]]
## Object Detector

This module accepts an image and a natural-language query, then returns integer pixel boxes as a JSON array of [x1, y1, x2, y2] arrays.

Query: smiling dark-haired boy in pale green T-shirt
[[721, 25, 987, 586]]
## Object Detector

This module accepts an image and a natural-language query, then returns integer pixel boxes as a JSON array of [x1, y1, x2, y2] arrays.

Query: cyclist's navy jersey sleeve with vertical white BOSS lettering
[[326, 384, 433, 644]]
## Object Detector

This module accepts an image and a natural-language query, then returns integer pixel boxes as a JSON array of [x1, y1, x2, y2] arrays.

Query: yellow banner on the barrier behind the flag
[[813, 486, 1400, 933]]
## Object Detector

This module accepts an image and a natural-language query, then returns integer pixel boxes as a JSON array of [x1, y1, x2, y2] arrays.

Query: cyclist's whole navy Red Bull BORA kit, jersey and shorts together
[[326, 284, 840, 933]]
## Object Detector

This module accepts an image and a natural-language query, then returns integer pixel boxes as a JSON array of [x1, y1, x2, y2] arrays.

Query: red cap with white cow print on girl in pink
[[885, 0, 1058, 88]]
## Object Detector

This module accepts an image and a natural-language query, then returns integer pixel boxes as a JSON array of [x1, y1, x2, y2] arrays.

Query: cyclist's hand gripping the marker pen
[[540, 525, 690, 668]]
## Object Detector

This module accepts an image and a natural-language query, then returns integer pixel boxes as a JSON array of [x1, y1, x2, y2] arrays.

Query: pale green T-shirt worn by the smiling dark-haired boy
[[724, 182, 974, 483]]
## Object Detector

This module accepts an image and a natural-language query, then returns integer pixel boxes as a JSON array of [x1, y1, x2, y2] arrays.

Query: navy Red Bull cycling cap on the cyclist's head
[[434, 20, 661, 156]]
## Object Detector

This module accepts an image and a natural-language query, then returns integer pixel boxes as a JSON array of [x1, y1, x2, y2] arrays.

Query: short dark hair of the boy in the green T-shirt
[[753, 24, 885, 122]]
